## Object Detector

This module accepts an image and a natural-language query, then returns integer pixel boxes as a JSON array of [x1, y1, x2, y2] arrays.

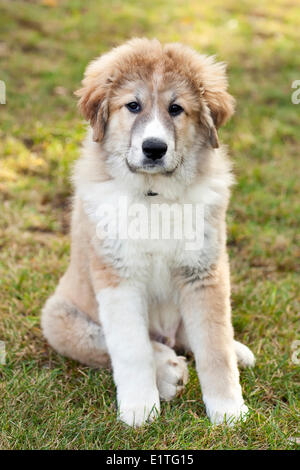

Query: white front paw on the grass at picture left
[[119, 393, 160, 428]]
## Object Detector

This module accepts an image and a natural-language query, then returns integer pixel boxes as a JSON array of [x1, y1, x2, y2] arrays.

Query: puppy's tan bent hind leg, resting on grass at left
[[41, 294, 109, 367]]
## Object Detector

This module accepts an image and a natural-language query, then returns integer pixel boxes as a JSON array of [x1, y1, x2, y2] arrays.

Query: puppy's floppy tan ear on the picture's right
[[200, 56, 235, 148]]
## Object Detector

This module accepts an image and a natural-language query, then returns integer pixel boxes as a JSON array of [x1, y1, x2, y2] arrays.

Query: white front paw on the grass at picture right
[[204, 398, 249, 426]]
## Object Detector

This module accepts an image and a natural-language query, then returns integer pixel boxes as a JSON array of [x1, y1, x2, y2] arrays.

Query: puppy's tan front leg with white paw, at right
[[181, 261, 248, 424]]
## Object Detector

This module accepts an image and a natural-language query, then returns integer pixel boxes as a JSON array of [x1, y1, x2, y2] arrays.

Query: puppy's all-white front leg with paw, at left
[[97, 283, 160, 426]]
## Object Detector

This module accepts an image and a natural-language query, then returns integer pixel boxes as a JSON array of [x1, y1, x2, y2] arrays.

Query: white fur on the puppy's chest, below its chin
[[77, 171, 230, 338]]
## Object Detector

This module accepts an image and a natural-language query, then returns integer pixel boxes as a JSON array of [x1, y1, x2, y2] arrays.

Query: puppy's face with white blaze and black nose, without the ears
[[103, 75, 201, 175]]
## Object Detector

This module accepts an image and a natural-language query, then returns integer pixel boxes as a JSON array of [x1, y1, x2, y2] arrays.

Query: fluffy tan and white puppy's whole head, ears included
[[76, 39, 234, 186]]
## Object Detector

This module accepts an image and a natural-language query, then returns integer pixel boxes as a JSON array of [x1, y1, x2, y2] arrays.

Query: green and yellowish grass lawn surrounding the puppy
[[0, 0, 300, 449]]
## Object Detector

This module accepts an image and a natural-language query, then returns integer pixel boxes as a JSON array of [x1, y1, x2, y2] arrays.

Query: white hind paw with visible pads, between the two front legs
[[155, 344, 189, 401]]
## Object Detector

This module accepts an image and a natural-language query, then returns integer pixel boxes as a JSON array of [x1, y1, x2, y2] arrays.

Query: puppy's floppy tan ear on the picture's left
[[75, 58, 112, 142]]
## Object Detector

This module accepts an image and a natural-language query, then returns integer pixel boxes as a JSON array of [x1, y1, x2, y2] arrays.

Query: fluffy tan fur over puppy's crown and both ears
[[76, 39, 234, 147]]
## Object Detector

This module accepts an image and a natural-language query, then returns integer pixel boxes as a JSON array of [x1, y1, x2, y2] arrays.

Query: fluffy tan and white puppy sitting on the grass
[[42, 39, 254, 426]]
